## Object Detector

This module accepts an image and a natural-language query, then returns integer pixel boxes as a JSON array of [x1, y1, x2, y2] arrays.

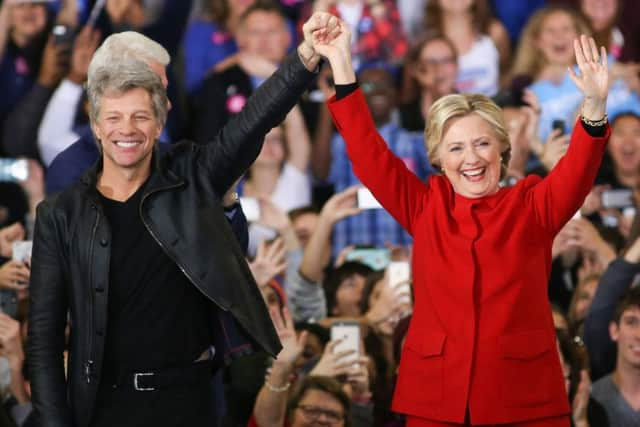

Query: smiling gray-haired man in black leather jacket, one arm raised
[[28, 13, 337, 427]]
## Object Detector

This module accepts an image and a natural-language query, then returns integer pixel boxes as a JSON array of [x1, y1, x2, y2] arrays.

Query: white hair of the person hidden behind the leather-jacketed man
[[87, 31, 171, 82]]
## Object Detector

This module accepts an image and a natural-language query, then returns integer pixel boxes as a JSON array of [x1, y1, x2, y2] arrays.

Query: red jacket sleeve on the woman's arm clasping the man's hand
[[329, 89, 428, 236]]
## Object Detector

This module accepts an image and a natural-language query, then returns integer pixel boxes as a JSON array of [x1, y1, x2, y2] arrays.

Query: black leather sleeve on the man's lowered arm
[[27, 202, 72, 427]]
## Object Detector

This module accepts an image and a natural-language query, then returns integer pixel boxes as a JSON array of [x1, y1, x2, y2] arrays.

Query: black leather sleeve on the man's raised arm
[[194, 52, 315, 196]]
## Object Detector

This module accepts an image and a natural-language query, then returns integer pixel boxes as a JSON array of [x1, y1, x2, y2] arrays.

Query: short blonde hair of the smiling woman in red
[[425, 93, 511, 179]]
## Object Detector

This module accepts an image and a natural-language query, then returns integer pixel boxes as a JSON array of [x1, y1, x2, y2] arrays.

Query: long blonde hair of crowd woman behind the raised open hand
[[511, 6, 591, 80]]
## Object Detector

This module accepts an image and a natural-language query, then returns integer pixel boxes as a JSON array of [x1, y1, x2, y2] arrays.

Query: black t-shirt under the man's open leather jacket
[[101, 185, 212, 381]]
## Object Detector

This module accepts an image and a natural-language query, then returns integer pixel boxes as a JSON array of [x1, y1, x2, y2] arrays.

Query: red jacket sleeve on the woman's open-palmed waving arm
[[529, 120, 611, 235]]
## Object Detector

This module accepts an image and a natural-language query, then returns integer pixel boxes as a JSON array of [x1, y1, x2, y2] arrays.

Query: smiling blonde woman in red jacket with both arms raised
[[314, 15, 610, 427]]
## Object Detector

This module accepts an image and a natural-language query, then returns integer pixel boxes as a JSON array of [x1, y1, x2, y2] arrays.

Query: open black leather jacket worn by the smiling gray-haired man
[[27, 53, 314, 427]]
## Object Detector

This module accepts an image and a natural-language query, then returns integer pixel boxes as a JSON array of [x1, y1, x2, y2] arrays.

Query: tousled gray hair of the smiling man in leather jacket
[[87, 58, 168, 127]]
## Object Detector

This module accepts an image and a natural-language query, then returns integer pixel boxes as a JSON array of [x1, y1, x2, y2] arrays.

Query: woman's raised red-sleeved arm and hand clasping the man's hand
[[313, 18, 427, 233]]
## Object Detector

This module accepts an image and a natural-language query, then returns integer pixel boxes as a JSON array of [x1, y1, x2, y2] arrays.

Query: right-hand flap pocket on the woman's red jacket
[[498, 330, 558, 407]]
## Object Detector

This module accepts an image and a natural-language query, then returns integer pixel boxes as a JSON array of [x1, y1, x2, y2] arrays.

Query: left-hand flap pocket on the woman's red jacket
[[398, 332, 446, 403]]
